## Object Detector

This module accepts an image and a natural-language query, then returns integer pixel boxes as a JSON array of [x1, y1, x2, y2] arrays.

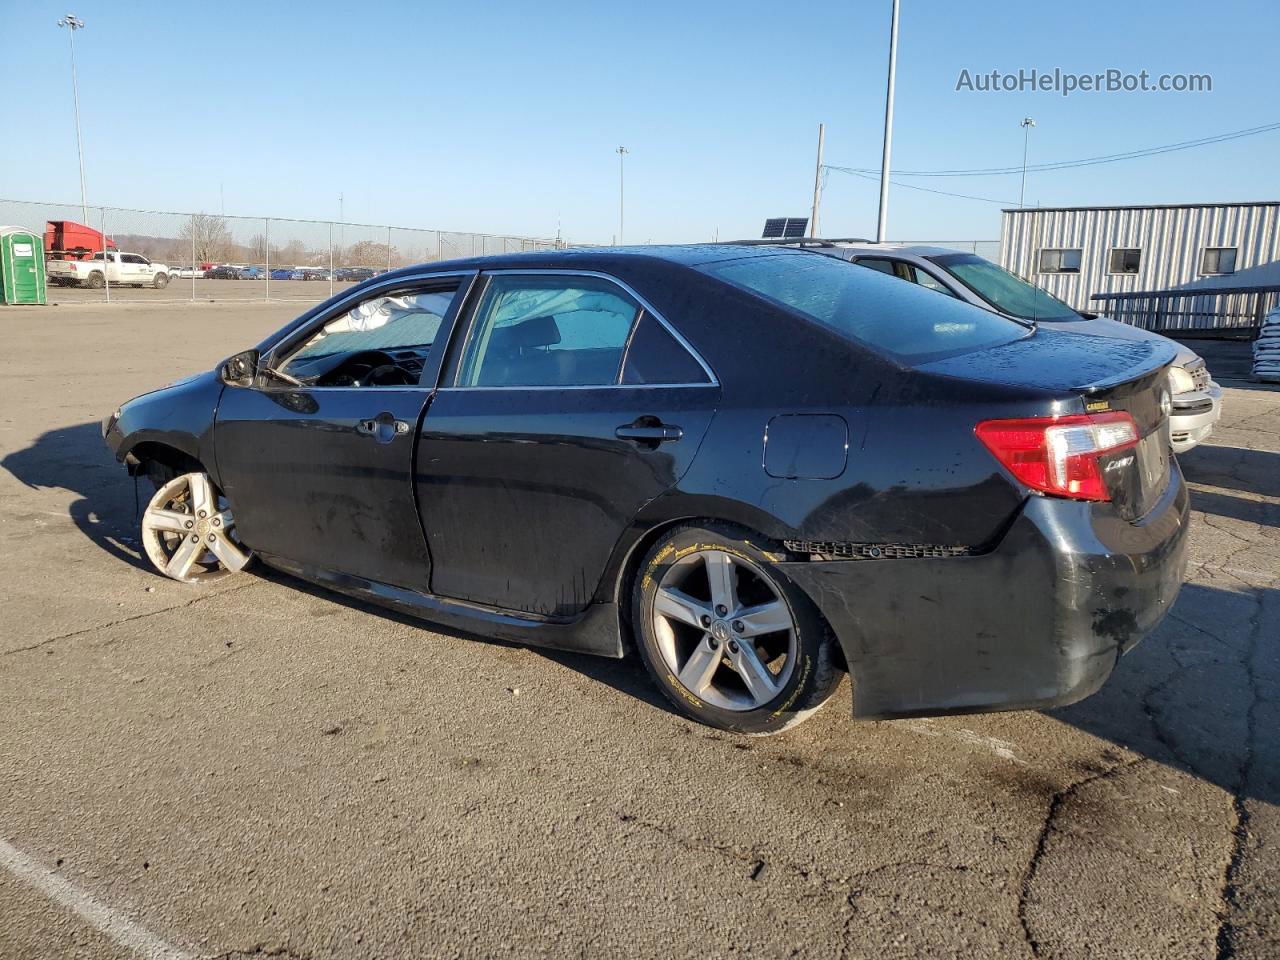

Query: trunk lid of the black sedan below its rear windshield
[[919, 328, 1178, 520]]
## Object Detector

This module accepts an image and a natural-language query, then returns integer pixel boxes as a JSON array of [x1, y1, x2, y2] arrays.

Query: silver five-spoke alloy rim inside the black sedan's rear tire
[[652, 548, 797, 710]]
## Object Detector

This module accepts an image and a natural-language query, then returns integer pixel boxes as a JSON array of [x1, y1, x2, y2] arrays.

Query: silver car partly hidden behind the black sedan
[[757, 241, 1222, 453]]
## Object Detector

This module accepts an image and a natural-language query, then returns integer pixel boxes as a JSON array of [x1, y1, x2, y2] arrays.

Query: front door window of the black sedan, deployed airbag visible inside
[[279, 285, 457, 387]]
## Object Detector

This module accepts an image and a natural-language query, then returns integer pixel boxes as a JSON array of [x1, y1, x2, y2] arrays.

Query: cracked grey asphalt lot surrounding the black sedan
[[0, 302, 1280, 960]]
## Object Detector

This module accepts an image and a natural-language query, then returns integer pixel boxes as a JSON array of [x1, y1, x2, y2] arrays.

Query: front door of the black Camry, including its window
[[214, 276, 470, 591]]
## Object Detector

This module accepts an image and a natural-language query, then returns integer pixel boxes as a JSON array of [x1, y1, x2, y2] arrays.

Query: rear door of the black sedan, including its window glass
[[417, 271, 719, 617]]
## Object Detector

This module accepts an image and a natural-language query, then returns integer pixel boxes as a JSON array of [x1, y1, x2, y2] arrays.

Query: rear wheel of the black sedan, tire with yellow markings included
[[631, 522, 842, 736]]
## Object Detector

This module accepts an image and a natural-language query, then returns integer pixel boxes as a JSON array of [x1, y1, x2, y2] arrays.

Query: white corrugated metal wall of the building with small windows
[[1000, 204, 1280, 310]]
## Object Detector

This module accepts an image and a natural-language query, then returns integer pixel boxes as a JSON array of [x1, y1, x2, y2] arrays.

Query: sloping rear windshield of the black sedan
[[700, 253, 1030, 362]]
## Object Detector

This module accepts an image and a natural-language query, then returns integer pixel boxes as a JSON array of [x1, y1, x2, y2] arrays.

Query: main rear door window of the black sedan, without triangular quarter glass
[[457, 274, 640, 387]]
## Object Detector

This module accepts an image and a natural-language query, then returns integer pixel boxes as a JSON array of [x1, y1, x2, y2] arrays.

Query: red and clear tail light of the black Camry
[[974, 413, 1138, 500]]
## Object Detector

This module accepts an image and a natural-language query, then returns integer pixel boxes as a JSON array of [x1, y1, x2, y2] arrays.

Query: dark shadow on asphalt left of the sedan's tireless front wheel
[[0, 422, 154, 570]]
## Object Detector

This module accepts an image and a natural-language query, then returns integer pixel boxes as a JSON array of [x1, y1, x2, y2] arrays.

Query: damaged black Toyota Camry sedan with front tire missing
[[104, 246, 1188, 733]]
